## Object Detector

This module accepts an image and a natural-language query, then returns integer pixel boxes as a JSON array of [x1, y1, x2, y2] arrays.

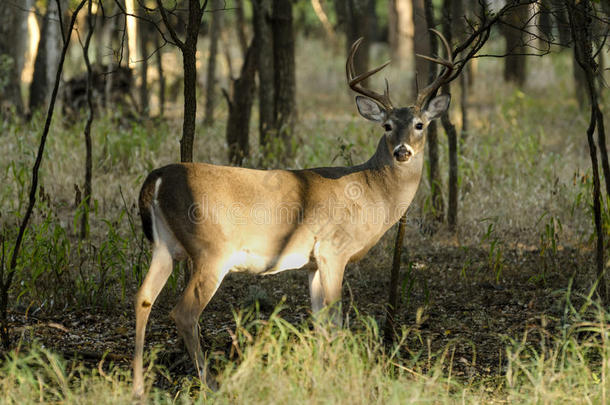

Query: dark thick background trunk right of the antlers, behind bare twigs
[[502, 5, 529, 86]]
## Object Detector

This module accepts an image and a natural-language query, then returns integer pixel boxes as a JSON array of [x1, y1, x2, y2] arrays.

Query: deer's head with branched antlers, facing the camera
[[346, 30, 453, 164]]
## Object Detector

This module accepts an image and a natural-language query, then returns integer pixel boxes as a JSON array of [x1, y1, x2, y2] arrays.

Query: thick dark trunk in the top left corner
[[0, 0, 32, 115]]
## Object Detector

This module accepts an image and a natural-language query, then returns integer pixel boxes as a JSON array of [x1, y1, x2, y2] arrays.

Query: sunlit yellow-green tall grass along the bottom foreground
[[0, 297, 610, 404]]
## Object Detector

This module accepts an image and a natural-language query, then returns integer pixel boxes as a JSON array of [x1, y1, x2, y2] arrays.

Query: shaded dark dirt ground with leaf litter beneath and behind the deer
[[4, 227, 593, 386]]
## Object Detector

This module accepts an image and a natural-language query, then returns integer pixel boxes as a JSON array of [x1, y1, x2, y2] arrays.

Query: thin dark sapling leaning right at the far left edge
[[0, 0, 87, 350]]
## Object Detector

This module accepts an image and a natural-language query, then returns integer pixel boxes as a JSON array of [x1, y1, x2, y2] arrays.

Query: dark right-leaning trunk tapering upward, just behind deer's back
[[224, 41, 256, 166]]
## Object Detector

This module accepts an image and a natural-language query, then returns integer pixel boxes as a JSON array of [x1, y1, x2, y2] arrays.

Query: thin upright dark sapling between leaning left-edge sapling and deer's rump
[[80, 0, 95, 239]]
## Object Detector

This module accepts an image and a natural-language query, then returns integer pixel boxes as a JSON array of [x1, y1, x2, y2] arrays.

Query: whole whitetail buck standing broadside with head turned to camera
[[133, 32, 453, 395]]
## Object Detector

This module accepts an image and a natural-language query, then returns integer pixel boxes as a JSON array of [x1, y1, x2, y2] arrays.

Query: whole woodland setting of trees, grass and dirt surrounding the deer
[[0, 0, 610, 403]]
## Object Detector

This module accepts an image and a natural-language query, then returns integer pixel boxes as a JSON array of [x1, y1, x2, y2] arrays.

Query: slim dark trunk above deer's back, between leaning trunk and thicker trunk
[[252, 0, 275, 148]]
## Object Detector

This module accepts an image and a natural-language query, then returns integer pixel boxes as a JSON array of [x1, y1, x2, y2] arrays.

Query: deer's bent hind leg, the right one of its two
[[170, 252, 227, 386]]
